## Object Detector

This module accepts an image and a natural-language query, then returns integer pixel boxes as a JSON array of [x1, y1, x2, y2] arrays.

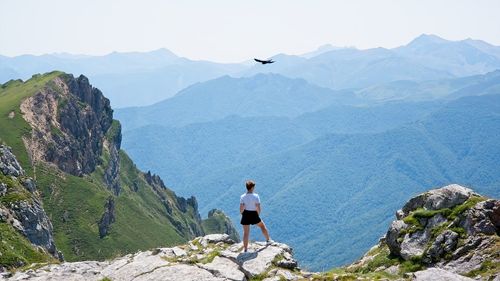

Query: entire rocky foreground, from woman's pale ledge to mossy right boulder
[[4, 185, 500, 281]]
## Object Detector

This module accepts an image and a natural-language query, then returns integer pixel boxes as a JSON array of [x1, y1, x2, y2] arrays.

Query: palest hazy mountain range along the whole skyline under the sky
[[0, 34, 500, 108]]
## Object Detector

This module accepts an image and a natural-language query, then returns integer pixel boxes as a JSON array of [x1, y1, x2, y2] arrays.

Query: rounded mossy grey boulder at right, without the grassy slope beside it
[[384, 185, 500, 280]]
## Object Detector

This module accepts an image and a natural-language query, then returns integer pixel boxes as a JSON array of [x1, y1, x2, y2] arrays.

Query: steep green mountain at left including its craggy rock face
[[0, 72, 239, 267]]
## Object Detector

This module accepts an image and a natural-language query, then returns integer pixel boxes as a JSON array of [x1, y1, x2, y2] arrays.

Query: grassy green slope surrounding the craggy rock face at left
[[0, 72, 234, 261]]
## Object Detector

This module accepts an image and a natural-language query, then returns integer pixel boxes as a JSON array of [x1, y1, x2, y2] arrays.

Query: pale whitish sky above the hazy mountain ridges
[[0, 0, 500, 62]]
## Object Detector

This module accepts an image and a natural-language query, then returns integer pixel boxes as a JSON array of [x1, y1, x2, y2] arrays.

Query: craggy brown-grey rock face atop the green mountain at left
[[21, 74, 113, 176]]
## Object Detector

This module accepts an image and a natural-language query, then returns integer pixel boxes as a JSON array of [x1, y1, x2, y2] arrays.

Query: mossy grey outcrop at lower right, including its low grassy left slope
[[350, 185, 500, 280]]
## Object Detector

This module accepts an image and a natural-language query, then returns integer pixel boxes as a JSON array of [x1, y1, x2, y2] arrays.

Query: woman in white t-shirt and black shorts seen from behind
[[240, 180, 272, 252]]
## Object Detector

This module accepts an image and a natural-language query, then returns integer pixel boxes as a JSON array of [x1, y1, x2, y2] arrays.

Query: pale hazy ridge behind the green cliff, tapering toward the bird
[[0, 49, 243, 108]]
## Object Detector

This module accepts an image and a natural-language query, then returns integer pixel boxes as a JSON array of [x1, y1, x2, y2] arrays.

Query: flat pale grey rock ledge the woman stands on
[[6, 234, 304, 281]]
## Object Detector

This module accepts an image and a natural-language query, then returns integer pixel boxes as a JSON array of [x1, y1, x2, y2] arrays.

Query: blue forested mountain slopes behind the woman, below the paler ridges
[[117, 71, 500, 270]]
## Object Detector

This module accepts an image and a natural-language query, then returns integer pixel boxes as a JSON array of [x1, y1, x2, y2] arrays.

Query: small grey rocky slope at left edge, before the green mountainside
[[0, 145, 63, 260]]
